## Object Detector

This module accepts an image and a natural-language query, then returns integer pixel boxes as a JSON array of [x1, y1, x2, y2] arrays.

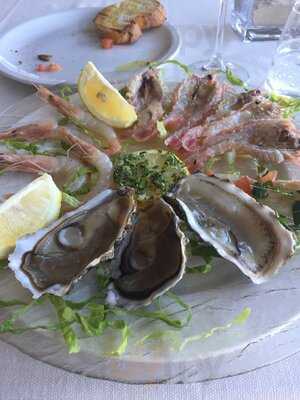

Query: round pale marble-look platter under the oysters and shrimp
[[0, 91, 300, 383]]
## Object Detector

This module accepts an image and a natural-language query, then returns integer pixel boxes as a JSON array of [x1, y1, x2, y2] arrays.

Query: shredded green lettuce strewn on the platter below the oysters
[[0, 253, 250, 356]]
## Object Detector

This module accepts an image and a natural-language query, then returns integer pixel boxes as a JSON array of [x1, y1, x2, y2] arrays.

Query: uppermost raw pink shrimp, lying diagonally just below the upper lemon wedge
[[37, 86, 121, 155]]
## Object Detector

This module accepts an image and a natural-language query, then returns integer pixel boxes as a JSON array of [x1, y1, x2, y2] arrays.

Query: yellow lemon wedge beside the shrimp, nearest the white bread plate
[[78, 62, 137, 128]]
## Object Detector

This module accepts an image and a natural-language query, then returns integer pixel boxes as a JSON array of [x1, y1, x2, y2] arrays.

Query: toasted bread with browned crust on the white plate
[[94, 0, 166, 44]]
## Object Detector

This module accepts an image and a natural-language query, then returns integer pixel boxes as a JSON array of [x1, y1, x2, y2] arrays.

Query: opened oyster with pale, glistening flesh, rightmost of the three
[[166, 173, 295, 283]]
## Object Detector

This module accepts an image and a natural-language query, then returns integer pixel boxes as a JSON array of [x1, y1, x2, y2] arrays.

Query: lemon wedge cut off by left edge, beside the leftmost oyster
[[0, 174, 62, 258]]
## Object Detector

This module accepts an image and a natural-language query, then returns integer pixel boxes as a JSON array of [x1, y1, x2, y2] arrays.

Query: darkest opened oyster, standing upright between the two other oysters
[[112, 199, 186, 305]]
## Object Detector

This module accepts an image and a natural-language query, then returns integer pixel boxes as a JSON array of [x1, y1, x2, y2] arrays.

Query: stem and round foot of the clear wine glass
[[191, 0, 249, 82]]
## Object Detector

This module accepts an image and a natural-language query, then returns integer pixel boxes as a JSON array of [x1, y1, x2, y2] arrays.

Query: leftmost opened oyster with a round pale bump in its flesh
[[9, 189, 135, 298]]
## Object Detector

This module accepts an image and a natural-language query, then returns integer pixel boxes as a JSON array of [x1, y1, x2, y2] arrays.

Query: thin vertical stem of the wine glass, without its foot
[[205, 0, 227, 70]]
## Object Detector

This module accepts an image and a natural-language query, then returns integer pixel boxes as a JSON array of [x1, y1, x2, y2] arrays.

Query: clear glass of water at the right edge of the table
[[265, 1, 300, 97]]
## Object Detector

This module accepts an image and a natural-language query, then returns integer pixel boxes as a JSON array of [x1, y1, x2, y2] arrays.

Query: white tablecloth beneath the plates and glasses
[[0, 0, 300, 400]]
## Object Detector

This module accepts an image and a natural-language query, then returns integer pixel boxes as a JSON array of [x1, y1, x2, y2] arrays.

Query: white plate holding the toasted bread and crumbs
[[0, 7, 181, 86]]
